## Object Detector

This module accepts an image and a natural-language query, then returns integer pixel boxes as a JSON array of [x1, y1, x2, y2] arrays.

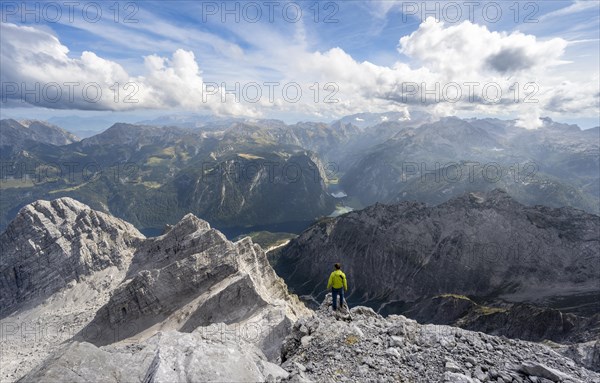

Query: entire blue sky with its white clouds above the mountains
[[0, 1, 600, 127]]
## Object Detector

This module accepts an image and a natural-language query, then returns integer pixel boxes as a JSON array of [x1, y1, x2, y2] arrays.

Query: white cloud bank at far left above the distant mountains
[[0, 23, 257, 116]]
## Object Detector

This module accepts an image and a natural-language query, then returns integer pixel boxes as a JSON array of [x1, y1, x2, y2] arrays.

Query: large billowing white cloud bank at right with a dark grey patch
[[288, 18, 598, 128]]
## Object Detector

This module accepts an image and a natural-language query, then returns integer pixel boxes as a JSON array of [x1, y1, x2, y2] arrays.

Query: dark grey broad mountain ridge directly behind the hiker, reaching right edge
[[275, 190, 600, 313]]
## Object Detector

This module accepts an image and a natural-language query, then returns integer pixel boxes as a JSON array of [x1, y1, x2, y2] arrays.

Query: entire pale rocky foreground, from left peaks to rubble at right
[[0, 198, 600, 382]]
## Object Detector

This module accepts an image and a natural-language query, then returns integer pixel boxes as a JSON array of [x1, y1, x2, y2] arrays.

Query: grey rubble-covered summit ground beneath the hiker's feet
[[282, 295, 600, 383]]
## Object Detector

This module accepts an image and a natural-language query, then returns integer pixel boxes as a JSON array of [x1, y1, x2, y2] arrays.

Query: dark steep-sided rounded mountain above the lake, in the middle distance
[[161, 151, 335, 227]]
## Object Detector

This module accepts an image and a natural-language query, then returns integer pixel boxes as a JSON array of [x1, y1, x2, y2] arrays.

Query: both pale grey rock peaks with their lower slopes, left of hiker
[[0, 198, 308, 379]]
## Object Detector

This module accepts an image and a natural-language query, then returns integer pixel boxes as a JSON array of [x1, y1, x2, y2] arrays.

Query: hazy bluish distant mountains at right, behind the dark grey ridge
[[341, 117, 600, 213]]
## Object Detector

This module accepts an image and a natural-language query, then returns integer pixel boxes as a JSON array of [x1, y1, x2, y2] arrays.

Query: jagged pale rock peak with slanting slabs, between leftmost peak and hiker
[[78, 214, 308, 359]]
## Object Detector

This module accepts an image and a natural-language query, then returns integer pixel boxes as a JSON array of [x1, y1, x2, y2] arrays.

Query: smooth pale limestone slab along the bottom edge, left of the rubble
[[20, 329, 288, 383]]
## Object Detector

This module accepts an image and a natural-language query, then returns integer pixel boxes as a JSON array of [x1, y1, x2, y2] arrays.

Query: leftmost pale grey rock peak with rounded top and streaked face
[[0, 198, 145, 318]]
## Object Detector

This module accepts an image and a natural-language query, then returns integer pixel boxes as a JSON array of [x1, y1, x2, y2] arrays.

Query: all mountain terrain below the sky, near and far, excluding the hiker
[[0, 112, 600, 382]]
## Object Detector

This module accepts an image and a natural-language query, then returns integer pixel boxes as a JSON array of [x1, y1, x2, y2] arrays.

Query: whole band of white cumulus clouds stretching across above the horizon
[[0, 18, 599, 128]]
